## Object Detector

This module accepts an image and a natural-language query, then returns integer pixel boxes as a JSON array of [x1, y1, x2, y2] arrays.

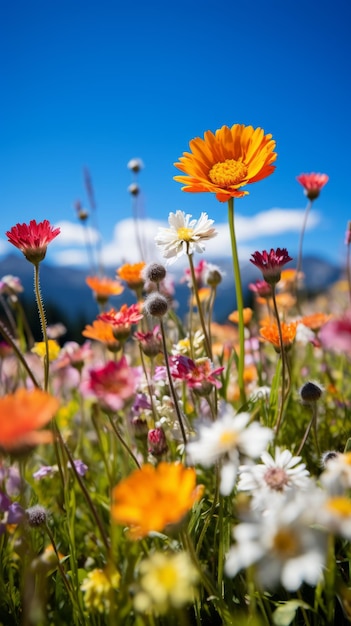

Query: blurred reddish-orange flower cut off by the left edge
[[0, 388, 60, 451]]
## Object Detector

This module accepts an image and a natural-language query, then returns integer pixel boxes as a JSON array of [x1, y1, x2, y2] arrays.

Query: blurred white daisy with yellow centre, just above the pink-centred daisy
[[186, 404, 273, 495]]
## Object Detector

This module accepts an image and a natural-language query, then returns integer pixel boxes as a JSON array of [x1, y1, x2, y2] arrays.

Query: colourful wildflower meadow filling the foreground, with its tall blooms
[[0, 124, 351, 626]]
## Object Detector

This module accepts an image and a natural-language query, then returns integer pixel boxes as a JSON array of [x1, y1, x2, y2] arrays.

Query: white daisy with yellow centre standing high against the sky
[[155, 211, 217, 264]]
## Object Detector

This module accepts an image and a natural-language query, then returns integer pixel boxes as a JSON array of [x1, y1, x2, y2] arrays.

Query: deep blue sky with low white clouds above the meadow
[[0, 0, 351, 266]]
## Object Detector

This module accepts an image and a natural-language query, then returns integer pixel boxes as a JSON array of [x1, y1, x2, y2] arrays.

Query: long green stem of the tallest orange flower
[[228, 198, 246, 404]]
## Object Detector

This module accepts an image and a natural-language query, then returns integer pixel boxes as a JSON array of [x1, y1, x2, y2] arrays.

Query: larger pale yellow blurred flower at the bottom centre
[[134, 552, 199, 614]]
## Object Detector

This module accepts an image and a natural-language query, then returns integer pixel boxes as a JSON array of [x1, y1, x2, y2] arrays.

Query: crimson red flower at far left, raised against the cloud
[[6, 220, 60, 265]]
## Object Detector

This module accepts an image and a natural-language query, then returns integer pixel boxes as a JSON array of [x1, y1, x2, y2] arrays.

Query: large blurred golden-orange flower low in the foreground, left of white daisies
[[111, 462, 202, 539]]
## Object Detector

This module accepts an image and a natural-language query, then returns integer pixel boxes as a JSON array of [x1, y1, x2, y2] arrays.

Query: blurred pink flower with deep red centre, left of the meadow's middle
[[81, 356, 138, 411]]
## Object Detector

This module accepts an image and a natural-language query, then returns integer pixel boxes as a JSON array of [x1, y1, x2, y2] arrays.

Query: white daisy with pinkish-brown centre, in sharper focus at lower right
[[238, 448, 310, 510]]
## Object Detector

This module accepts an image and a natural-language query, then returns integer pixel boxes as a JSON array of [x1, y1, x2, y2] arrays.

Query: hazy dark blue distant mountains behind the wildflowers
[[0, 254, 342, 327]]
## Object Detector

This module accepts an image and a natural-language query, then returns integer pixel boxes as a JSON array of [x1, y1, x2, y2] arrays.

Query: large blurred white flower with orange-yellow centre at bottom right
[[225, 490, 327, 591]]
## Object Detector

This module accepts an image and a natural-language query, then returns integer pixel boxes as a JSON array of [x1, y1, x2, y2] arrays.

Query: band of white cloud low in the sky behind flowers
[[48, 208, 320, 267]]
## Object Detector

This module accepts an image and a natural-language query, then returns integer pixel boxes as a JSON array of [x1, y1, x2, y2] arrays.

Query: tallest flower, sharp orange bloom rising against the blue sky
[[174, 124, 277, 202]]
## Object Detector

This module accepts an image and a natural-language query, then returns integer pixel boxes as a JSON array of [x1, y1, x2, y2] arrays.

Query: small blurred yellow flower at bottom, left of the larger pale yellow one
[[80, 566, 121, 613]]
